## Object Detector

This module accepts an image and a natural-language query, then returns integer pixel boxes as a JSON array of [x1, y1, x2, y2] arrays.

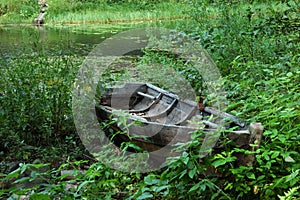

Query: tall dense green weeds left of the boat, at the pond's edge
[[0, 52, 79, 145]]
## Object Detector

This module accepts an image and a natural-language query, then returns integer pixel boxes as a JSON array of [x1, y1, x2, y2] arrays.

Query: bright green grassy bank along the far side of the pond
[[0, 0, 186, 24]]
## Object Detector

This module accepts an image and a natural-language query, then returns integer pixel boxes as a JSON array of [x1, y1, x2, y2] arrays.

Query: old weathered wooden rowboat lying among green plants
[[96, 83, 262, 166]]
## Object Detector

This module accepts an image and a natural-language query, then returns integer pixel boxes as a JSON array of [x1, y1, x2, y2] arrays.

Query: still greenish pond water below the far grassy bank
[[0, 21, 180, 57]]
